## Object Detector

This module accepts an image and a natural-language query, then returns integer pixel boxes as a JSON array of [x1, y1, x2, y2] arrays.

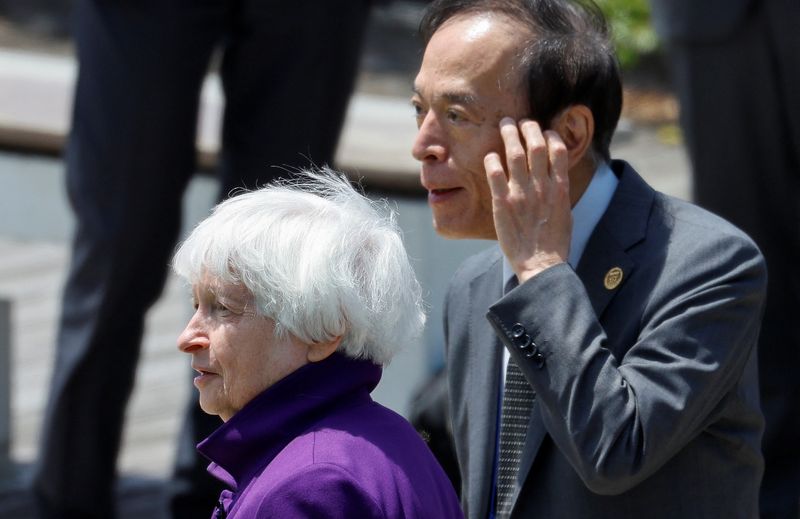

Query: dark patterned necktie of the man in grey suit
[[495, 277, 534, 519]]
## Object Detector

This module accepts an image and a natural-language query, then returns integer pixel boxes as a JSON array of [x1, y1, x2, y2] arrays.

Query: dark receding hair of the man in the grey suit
[[419, 0, 622, 161]]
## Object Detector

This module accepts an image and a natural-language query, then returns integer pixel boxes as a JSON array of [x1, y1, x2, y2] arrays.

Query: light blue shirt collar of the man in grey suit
[[503, 162, 619, 287]]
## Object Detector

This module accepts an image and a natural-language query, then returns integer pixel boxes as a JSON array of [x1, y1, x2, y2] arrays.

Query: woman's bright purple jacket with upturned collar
[[197, 353, 463, 519]]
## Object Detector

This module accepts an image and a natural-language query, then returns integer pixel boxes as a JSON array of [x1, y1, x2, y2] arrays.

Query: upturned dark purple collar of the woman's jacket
[[197, 353, 382, 490]]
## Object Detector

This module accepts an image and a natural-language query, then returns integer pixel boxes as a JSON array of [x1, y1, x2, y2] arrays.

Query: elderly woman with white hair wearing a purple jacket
[[173, 170, 462, 519]]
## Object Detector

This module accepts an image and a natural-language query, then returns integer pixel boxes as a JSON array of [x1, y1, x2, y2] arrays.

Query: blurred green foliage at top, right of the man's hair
[[595, 0, 658, 69]]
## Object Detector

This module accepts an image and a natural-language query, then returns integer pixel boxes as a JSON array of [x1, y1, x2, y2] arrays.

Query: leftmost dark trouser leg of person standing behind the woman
[[34, 0, 222, 519]]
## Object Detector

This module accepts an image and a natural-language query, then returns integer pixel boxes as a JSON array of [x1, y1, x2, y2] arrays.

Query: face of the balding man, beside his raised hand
[[412, 14, 527, 239]]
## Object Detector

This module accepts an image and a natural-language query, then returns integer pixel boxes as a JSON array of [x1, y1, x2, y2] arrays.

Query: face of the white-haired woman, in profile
[[178, 276, 308, 422]]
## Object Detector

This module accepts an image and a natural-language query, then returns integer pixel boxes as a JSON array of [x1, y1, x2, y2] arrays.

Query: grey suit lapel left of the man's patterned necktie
[[467, 253, 503, 517]]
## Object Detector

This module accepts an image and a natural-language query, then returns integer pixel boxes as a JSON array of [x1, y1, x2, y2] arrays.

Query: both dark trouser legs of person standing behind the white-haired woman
[[33, 0, 369, 518]]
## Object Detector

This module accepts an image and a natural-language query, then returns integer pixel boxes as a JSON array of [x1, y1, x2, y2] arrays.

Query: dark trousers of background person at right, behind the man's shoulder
[[670, 0, 800, 519]]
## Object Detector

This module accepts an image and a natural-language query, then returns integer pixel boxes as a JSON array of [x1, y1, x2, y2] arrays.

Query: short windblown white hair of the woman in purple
[[173, 168, 425, 365]]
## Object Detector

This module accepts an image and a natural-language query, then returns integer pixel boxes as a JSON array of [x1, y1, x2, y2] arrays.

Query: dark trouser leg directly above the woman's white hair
[[216, 0, 370, 187]]
